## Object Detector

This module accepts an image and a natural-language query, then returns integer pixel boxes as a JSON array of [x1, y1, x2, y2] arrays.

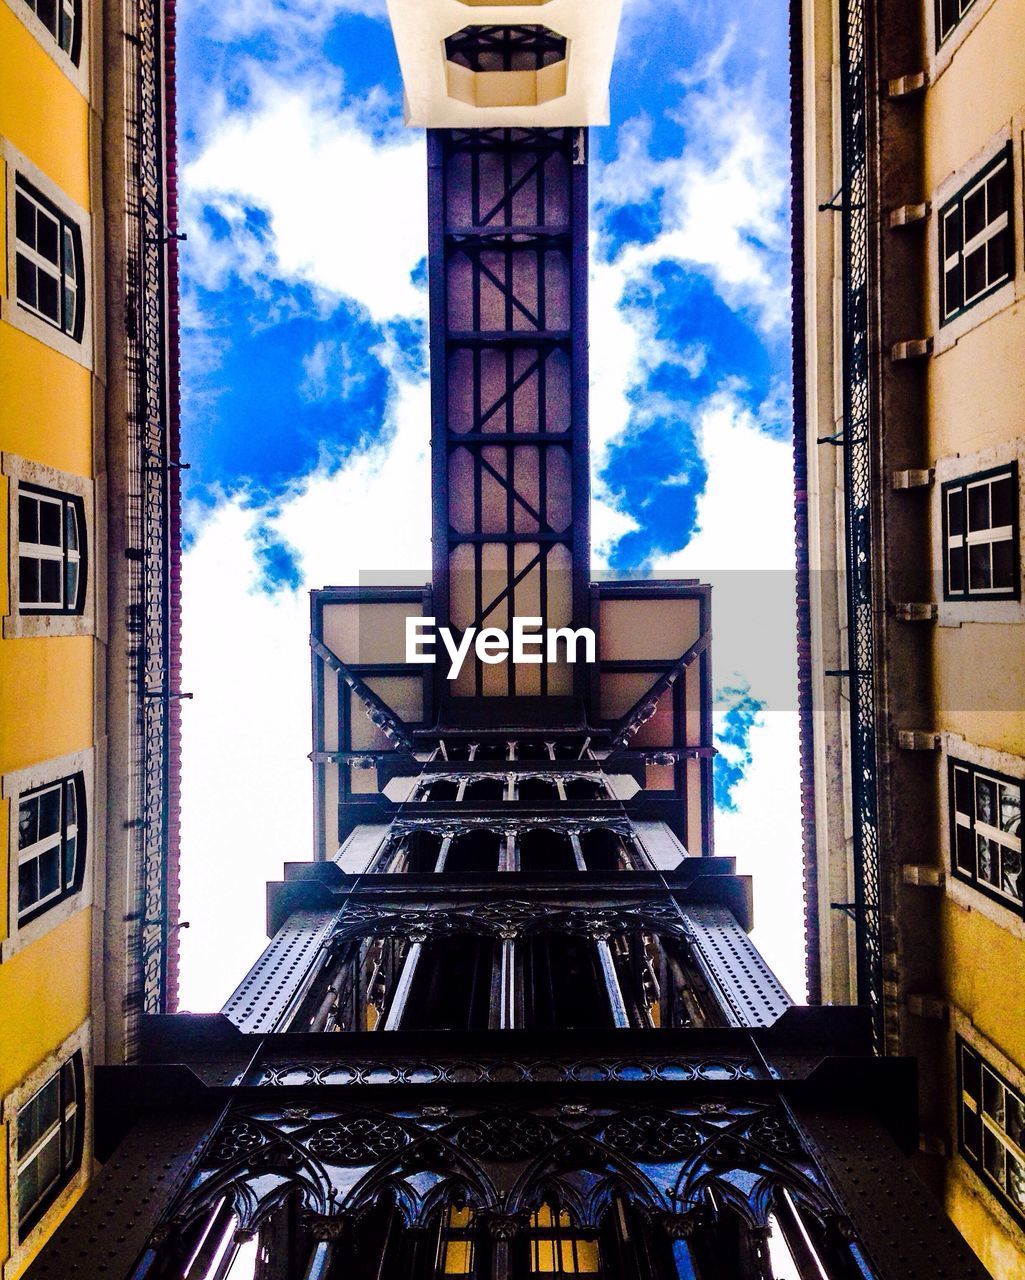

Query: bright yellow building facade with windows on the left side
[[0, 0, 177, 1280]]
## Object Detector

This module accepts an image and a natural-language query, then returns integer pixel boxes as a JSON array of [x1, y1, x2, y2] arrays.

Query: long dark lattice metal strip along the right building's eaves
[[841, 0, 883, 1048]]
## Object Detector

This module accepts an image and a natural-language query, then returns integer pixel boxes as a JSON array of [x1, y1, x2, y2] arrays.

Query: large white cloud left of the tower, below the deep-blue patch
[[182, 371, 430, 1010]]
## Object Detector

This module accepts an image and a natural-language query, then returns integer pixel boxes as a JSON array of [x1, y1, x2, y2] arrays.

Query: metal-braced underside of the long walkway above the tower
[[429, 129, 589, 696]]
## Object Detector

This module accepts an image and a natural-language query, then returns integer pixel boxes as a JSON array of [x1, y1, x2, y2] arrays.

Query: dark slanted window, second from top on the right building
[[939, 143, 1015, 324]]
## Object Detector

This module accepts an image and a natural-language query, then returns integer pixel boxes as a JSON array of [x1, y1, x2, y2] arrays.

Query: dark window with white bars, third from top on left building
[[18, 484, 86, 613]]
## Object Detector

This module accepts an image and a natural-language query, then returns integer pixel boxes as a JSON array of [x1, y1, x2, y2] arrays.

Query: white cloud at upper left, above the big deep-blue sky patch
[[182, 76, 427, 321]]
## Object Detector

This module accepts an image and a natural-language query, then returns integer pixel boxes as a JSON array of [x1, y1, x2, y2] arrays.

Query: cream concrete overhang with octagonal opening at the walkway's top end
[[388, 0, 622, 129]]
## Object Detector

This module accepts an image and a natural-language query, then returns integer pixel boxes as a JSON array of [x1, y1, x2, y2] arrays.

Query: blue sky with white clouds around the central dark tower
[[171, 0, 804, 1010]]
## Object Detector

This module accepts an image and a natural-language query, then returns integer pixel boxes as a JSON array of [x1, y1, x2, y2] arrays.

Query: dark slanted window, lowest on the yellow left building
[[17, 1053, 82, 1240]]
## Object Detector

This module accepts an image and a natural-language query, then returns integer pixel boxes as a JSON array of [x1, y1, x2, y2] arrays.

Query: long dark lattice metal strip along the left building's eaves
[[125, 0, 178, 1014]]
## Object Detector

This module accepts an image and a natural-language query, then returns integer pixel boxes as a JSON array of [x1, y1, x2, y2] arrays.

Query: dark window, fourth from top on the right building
[[950, 760, 1022, 910]]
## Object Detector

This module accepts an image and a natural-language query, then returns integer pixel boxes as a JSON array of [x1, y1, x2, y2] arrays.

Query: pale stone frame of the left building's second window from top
[[0, 142, 93, 369]]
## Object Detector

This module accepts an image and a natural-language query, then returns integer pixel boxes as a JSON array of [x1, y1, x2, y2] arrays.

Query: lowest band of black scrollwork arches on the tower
[[169, 1094, 839, 1239]]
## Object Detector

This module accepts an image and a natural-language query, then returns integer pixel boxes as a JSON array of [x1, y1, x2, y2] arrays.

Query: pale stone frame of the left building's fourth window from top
[[0, 748, 94, 964]]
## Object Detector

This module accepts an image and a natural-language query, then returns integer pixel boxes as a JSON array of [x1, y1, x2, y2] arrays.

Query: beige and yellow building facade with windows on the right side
[[792, 0, 1025, 1280]]
